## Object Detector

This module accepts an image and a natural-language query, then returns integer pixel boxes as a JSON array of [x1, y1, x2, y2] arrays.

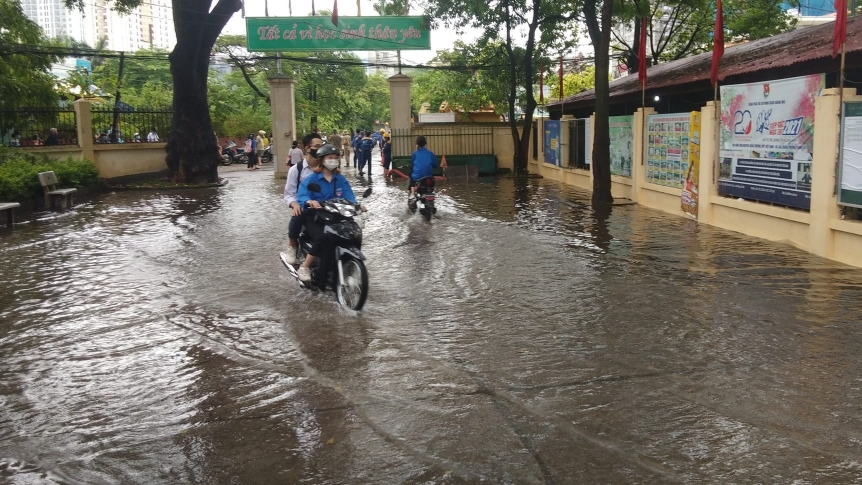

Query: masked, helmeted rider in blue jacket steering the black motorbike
[[296, 145, 365, 282]]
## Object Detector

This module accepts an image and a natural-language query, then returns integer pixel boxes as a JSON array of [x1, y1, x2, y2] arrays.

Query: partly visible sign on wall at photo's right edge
[[838, 101, 862, 207]]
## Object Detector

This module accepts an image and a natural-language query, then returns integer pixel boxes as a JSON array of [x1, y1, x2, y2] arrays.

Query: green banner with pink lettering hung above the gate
[[245, 17, 431, 51]]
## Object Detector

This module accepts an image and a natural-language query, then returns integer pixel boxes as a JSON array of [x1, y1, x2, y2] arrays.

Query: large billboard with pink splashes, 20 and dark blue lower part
[[718, 74, 824, 209]]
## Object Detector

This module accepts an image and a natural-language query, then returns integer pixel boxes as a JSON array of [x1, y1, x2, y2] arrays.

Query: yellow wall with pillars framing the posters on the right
[[528, 89, 862, 267]]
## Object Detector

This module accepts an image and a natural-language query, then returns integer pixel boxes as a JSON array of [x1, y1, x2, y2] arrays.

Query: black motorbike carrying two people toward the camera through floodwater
[[279, 183, 371, 311]]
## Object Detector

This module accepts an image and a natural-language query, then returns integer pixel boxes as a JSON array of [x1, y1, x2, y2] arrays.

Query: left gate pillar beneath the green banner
[[269, 75, 302, 178]]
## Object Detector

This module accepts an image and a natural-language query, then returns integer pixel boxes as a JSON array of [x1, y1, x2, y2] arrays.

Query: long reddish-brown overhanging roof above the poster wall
[[547, 16, 862, 113]]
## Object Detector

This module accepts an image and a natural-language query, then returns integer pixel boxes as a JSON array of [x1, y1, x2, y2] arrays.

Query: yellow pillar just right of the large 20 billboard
[[808, 88, 856, 259]]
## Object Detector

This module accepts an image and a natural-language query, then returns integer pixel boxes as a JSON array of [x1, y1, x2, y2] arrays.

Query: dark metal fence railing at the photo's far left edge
[[0, 108, 78, 147]]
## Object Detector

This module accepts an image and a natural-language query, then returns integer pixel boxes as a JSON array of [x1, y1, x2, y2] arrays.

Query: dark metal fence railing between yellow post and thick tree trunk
[[90, 105, 172, 143]]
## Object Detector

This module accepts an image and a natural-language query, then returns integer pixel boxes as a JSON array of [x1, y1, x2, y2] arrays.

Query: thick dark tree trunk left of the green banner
[[165, 0, 241, 184]]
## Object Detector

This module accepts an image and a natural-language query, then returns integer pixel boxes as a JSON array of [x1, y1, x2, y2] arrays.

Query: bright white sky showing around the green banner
[[222, 0, 481, 64]]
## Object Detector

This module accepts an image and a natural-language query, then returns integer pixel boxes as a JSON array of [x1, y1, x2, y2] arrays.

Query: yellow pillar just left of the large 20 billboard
[[697, 101, 720, 224]]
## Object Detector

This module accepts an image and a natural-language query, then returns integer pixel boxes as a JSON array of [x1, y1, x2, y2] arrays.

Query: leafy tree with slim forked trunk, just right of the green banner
[[428, 0, 578, 173]]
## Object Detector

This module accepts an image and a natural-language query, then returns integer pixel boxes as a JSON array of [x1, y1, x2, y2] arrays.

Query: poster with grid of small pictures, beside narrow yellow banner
[[646, 113, 691, 189]]
